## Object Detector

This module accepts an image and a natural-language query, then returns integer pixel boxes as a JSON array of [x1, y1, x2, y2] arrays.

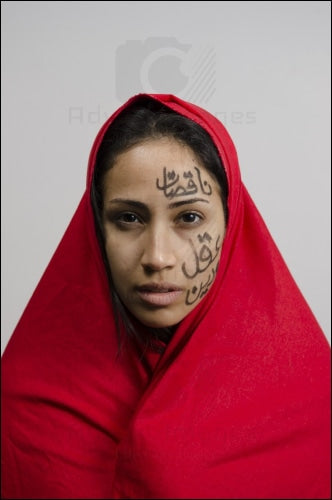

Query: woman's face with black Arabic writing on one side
[[103, 137, 225, 328]]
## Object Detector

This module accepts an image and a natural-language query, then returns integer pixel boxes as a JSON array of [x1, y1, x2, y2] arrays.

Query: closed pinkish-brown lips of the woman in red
[[136, 282, 183, 307]]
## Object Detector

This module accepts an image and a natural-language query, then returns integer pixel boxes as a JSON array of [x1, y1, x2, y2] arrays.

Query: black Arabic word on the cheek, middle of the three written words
[[181, 232, 221, 279]]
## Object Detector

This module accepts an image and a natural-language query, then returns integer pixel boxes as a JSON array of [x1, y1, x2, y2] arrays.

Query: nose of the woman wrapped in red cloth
[[141, 227, 176, 272]]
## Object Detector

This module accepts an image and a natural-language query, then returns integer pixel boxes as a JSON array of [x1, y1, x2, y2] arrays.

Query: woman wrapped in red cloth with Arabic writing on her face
[[2, 95, 330, 498]]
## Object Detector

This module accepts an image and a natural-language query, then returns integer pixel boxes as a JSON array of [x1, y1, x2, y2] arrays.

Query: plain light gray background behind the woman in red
[[1, 1, 331, 351]]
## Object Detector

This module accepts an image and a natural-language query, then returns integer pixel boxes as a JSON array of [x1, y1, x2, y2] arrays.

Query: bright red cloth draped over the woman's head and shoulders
[[2, 95, 330, 499]]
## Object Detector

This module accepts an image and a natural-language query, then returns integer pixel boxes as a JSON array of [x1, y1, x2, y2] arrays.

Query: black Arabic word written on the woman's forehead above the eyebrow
[[156, 167, 212, 199]]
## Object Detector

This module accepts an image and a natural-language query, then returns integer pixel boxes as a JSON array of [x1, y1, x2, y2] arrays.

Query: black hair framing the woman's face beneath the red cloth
[[91, 97, 228, 352]]
